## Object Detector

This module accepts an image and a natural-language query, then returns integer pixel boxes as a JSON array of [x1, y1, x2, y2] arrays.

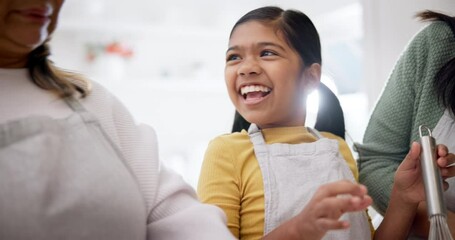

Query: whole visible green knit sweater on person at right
[[355, 22, 455, 214]]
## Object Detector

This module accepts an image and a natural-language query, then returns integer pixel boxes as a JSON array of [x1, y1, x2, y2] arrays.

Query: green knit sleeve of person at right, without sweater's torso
[[355, 27, 422, 214]]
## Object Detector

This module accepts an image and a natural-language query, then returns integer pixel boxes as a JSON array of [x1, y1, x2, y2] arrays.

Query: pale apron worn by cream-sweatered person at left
[[0, 98, 146, 240]]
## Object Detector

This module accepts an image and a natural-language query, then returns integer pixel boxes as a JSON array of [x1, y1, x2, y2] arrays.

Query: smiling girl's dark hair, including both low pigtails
[[231, 6, 345, 139]]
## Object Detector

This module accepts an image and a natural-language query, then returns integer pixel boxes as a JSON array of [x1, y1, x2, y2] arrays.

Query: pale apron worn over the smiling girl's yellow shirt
[[248, 124, 371, 240]]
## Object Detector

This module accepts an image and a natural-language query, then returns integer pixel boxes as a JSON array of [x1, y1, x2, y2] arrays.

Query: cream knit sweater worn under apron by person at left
[[0, 69, 233, 239]]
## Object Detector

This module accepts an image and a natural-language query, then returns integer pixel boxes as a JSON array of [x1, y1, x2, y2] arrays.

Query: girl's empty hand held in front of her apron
[[291, 180, 372, 239]]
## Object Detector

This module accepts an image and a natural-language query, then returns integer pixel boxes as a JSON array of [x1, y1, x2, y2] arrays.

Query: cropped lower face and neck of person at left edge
[[0, 0, 63, 67]]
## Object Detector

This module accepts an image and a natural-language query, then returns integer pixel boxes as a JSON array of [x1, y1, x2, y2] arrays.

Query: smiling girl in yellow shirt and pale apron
[[198, 7, 438, 239]]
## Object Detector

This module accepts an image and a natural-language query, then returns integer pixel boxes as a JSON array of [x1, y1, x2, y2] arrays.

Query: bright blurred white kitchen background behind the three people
[[52, 0, 455, 193]]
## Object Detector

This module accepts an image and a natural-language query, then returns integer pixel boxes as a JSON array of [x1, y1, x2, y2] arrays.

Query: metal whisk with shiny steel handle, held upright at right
[[419, 125, 453, 240]]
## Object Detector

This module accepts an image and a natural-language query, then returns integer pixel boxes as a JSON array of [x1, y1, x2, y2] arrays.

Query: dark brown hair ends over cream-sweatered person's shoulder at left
[[27, 43, 90, 97]]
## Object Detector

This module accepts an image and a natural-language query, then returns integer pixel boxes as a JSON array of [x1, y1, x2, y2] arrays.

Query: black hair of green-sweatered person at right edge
[[417, 10, 455, 114]]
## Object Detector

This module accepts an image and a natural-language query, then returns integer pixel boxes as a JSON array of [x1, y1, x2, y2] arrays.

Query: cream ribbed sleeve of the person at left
[[82, 84, 234, 240]]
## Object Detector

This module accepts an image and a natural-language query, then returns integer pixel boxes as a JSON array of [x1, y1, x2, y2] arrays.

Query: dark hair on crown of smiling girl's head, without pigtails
[[231, 6, 322, 66]]
